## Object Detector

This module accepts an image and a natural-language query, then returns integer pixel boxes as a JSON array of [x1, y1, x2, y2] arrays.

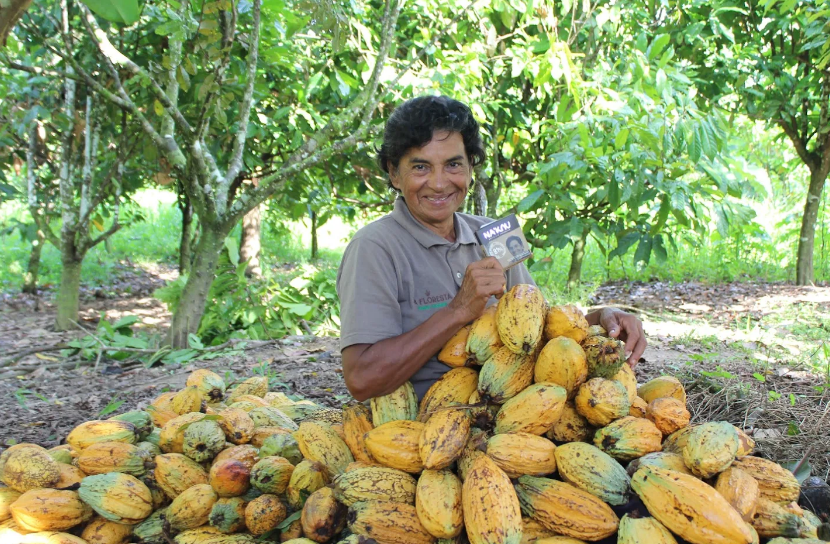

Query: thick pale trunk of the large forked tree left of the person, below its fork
[[167, 225, 230, 349]]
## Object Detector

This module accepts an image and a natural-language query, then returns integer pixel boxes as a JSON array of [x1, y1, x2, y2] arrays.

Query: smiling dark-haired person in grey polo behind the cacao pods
[[337, 96, 645, 400]]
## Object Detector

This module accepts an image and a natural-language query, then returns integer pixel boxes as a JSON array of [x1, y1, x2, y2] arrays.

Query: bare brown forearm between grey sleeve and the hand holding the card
[[342, 306, 474, 401]]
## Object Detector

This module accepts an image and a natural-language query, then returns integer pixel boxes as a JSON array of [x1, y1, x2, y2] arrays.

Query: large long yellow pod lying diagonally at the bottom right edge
[[631, 466, 757, 544]]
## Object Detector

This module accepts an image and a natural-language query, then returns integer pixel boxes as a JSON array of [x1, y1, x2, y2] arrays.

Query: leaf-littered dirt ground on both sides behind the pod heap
[[0, 274, 830, 479]]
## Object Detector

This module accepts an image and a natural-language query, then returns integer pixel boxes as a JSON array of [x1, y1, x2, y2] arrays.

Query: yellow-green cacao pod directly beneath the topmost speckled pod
[[478, 346, 535, 403]]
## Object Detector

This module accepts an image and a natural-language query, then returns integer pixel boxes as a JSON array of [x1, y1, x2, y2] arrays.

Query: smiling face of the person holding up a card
[[390, 131, 472, 237]]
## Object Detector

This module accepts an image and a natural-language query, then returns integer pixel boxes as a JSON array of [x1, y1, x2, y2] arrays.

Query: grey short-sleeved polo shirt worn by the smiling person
[[337, 197, 535, 398]]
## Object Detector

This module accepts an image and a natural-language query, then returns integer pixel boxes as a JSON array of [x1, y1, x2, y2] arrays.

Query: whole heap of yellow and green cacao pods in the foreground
[[0, 285, 826, 544]]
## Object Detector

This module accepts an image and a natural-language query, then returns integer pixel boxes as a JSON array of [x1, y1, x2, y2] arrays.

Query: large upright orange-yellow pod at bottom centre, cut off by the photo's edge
[[462, 455, 522, 544]]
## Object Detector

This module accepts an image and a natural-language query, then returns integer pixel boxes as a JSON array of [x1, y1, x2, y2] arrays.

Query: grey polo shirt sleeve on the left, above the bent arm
[[337, 238, 403, 349]]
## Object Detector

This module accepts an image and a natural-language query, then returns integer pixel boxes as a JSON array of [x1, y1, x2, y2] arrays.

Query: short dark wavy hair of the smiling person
[[377, 96, 486, 190]]
